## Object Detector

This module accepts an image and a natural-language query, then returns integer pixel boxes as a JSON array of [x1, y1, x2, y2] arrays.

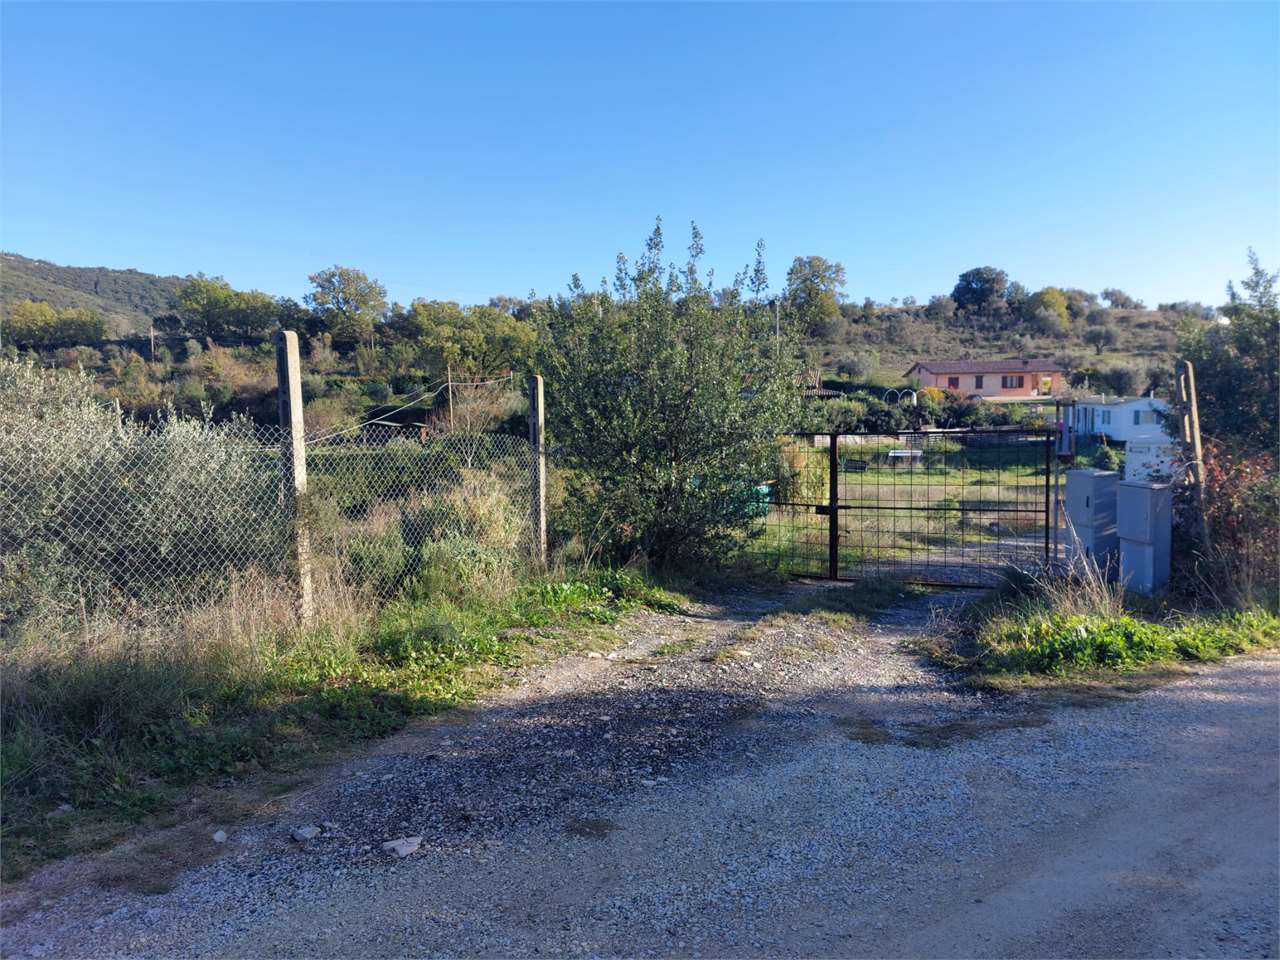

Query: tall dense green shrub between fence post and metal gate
[[538, 223, 800, 563]]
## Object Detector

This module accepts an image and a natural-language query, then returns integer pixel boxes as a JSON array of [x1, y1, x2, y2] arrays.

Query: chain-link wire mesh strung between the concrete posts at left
[[0, 407, 534, 635]]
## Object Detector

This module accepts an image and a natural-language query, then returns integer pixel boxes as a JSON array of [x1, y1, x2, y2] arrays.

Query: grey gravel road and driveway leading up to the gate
[[4, 585, 1280, 957]]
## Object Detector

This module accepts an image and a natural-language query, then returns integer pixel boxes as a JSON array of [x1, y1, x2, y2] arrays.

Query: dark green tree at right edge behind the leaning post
[[1178, 248, 1280, 452]]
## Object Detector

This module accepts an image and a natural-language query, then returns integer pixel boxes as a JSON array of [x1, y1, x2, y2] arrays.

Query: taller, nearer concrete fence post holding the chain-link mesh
[[275, 330, 315, 626]]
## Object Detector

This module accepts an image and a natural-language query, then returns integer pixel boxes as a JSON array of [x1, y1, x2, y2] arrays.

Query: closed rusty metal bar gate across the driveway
[[753, 429, 1056, 586]]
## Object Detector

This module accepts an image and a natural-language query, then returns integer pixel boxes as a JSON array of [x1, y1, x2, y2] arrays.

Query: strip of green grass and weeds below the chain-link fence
[[0, 571, 681, 878]]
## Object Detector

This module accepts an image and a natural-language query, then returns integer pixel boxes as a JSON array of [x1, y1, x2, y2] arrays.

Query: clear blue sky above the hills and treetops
[[0, 3, 1280, 308]]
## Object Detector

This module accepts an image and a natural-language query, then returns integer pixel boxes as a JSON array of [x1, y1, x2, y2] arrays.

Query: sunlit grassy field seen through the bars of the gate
[[748, 438, 1052, 575]]
